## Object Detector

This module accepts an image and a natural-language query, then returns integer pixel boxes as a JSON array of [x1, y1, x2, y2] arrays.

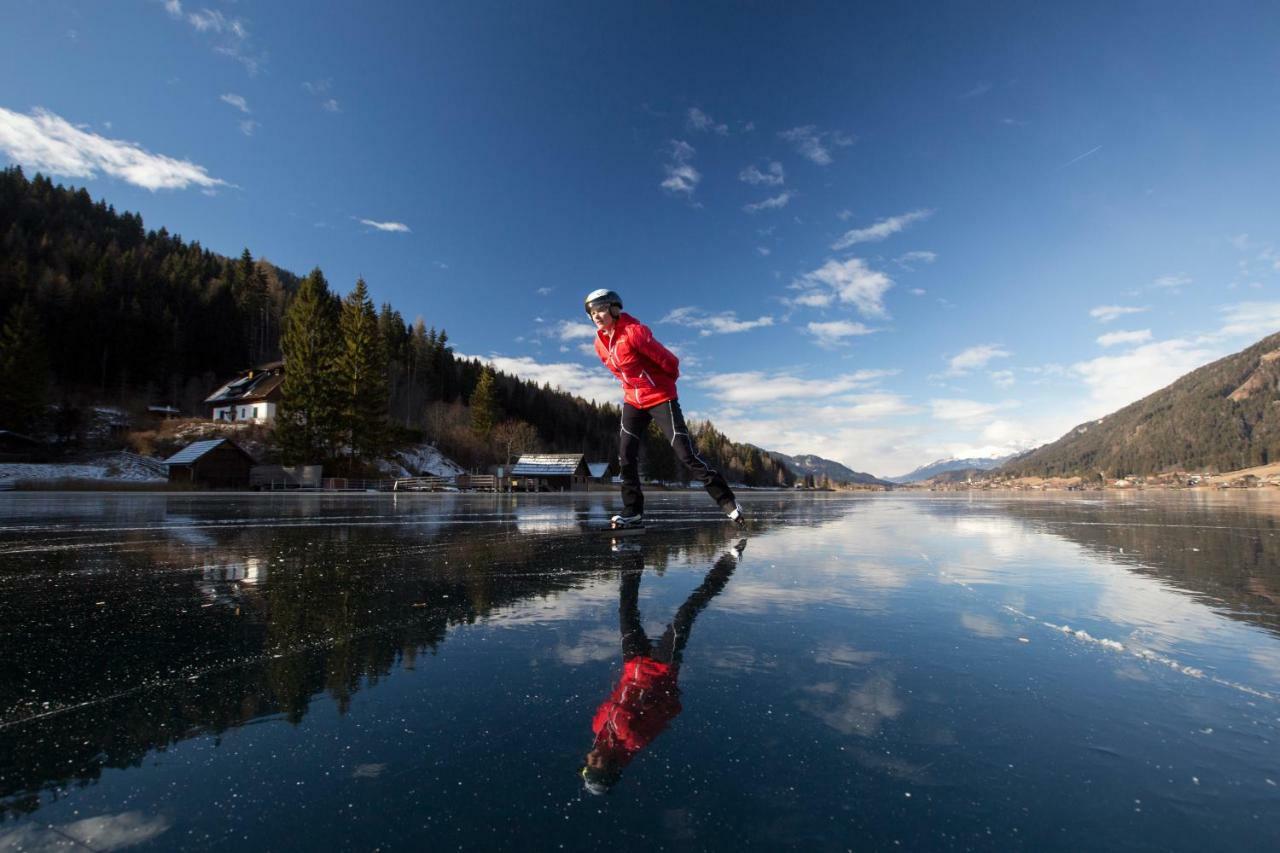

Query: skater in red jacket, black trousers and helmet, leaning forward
[[584, 289, 746, 528]]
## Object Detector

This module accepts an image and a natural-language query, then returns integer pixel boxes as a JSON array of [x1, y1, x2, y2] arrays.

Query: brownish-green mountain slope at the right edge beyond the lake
[[1000, 333, 1280, 476]]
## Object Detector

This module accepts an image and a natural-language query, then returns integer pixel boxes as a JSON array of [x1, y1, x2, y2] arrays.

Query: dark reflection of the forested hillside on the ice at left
[[0, 498, 768, 817]]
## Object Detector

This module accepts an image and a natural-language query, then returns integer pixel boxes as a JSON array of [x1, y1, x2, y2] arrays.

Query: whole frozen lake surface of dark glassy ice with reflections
[[0, 493, 1280, 850]]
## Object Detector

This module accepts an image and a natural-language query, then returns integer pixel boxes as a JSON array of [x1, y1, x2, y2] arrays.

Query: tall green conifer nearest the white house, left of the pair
[[275, 266, 339, 464]]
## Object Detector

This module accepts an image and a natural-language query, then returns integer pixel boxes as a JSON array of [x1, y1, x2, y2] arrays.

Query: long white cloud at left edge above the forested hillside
[[0, 106, 230, 192]]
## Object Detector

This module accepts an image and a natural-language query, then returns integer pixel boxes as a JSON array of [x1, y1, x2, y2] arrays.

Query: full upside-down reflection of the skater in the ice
[[582, 539, 746, 794]]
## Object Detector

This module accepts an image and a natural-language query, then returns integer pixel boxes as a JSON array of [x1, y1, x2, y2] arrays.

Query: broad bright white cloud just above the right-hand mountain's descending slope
[[1071, 338, 1215, 416]]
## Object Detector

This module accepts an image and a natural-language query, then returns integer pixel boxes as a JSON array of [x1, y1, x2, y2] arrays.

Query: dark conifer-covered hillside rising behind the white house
[[0, 167, 795, 485]]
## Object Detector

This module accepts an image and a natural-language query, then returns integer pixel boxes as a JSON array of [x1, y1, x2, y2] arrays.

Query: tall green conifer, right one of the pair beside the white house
[[337, 278, 388, 467]]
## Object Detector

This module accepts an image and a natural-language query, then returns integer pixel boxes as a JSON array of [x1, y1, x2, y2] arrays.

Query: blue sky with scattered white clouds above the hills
[[0, 0, 1280, 476]]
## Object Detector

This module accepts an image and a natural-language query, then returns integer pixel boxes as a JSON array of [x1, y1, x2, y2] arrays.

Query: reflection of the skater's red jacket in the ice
[[591, 656, 680, 765]]
